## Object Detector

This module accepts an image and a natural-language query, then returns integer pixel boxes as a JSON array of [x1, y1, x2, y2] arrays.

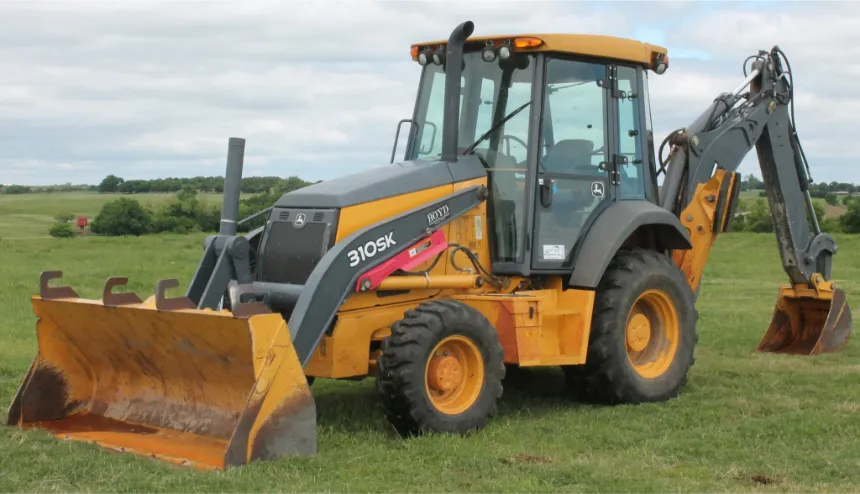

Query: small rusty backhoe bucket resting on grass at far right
[[756, 284, 851, 355]]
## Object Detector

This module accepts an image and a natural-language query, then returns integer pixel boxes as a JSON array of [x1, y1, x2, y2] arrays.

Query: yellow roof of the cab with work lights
[[411, 34, 667, 68]]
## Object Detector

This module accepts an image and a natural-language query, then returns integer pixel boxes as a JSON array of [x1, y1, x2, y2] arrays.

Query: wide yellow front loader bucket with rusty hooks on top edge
[[8, 273, 316, 469]]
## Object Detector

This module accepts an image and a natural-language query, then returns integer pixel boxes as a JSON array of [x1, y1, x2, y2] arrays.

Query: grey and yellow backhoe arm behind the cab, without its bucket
[[661, 47, 836, 290]]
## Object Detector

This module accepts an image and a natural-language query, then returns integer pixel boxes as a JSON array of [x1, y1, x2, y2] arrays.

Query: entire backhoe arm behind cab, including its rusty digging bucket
[[660, 47, 851, 354]]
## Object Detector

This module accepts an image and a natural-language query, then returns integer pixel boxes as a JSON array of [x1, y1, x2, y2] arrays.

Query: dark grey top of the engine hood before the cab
[[275, 155, 487, 208]]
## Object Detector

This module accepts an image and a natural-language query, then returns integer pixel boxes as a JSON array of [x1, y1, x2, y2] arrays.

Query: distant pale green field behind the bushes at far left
[[0, 192, 221, 240]]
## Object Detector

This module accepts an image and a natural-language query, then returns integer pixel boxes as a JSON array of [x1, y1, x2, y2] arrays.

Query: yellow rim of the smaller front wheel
[[424, 336, 484, 415]]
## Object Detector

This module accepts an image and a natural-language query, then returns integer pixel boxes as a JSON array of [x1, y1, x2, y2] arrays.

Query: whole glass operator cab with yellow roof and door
[[406, 35, 665, 276]]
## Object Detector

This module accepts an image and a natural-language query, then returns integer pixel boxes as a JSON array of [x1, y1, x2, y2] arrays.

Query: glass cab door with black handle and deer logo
[[531, 56, 616, 272]]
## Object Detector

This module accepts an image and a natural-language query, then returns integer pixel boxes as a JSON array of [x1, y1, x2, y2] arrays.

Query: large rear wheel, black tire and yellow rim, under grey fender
[[564, 249, 698, 405]]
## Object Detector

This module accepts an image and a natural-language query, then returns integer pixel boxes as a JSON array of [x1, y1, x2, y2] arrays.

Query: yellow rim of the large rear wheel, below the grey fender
[[625, 290, 681, 379]]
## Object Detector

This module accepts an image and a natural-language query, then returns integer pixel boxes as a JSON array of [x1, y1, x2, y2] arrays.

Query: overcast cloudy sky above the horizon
[[0, 0, 860, 184]]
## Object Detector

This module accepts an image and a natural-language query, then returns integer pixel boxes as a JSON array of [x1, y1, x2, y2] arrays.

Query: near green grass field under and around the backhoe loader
[[0, 234, 860, 493]]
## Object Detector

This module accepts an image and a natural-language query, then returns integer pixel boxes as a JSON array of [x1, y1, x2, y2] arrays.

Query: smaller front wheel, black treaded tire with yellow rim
[[376, 300, 505, 436]]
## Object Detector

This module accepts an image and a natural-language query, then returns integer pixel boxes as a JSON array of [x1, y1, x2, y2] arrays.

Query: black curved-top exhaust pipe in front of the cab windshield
[[442, 21, 475, 163]]
